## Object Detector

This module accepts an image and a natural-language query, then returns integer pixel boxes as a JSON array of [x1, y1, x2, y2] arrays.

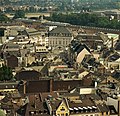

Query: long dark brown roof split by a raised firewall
[[26, 79, 82, 93]]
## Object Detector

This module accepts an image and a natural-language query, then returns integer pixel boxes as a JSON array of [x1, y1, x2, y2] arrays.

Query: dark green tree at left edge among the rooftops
[[0, 65, 13, 81]]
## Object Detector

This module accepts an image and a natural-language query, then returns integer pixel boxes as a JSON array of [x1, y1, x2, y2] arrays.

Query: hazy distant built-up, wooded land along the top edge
[[0, 0, 120, 11]]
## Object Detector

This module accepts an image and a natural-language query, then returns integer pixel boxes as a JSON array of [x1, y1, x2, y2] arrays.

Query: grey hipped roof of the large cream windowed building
[[49, 27, 71, 34]]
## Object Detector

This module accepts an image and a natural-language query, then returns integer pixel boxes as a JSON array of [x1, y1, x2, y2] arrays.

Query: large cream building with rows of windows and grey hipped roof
[[48, 27, 73, 48]]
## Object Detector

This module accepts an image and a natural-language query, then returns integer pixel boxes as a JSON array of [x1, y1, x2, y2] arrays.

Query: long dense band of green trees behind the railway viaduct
[[44, 13, 120, 29]]
